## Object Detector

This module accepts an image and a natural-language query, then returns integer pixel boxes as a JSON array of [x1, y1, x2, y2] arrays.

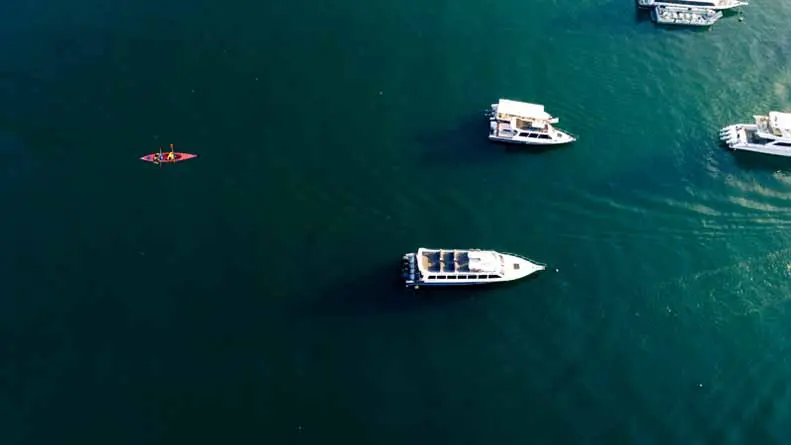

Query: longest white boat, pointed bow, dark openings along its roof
[[401, 247, 546, 289]]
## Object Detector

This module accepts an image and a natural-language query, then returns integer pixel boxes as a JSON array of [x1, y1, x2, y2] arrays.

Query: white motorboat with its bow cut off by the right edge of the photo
[[720, 111, 791, 156]]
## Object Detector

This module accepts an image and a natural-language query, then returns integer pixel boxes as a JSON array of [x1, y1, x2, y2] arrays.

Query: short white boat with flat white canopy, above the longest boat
[[489, 99, 576, 145]]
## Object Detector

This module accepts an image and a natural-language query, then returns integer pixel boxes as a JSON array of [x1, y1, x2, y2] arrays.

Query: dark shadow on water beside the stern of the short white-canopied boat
[[417, 112, 501, 165]]
